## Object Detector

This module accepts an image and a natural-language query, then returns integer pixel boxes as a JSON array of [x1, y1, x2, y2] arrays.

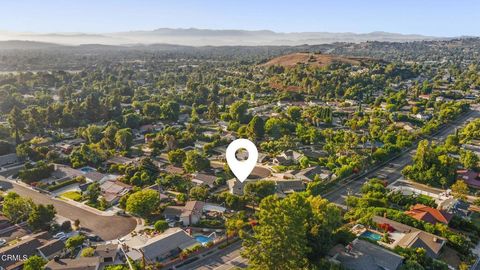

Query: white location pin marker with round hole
[[226, 139, 258, 182]]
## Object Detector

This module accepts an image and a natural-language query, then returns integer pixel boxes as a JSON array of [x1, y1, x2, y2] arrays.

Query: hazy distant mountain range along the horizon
[[0, 28, 449, 46]]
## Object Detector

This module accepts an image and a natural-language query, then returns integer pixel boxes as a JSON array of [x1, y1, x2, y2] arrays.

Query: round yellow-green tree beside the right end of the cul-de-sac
[[126, 189, 160, 218]]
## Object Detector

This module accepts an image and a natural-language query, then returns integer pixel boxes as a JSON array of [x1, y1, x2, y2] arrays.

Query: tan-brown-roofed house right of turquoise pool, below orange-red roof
[[372, 216, 447, 258]]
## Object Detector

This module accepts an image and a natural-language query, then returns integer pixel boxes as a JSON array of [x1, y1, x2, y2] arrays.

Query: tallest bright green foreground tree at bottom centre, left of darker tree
[[242, 193, 311, 270]]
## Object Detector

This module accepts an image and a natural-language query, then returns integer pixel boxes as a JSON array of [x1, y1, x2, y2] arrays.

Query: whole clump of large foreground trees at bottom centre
[[240, 193, 342, 269]]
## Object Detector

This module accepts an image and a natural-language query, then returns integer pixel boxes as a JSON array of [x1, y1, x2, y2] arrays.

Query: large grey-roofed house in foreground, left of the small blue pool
[[126, 227, 198, 262]]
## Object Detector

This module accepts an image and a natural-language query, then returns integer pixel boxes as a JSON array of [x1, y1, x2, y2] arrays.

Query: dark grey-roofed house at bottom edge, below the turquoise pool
[[329, 238, 404, 270]]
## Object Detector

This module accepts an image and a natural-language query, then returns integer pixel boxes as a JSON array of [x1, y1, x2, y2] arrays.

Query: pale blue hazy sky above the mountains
[[0, 0, 480, 36]]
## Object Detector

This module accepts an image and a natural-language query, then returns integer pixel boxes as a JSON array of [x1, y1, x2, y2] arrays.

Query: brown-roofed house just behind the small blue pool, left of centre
[[163, 201, 205, 226]]
